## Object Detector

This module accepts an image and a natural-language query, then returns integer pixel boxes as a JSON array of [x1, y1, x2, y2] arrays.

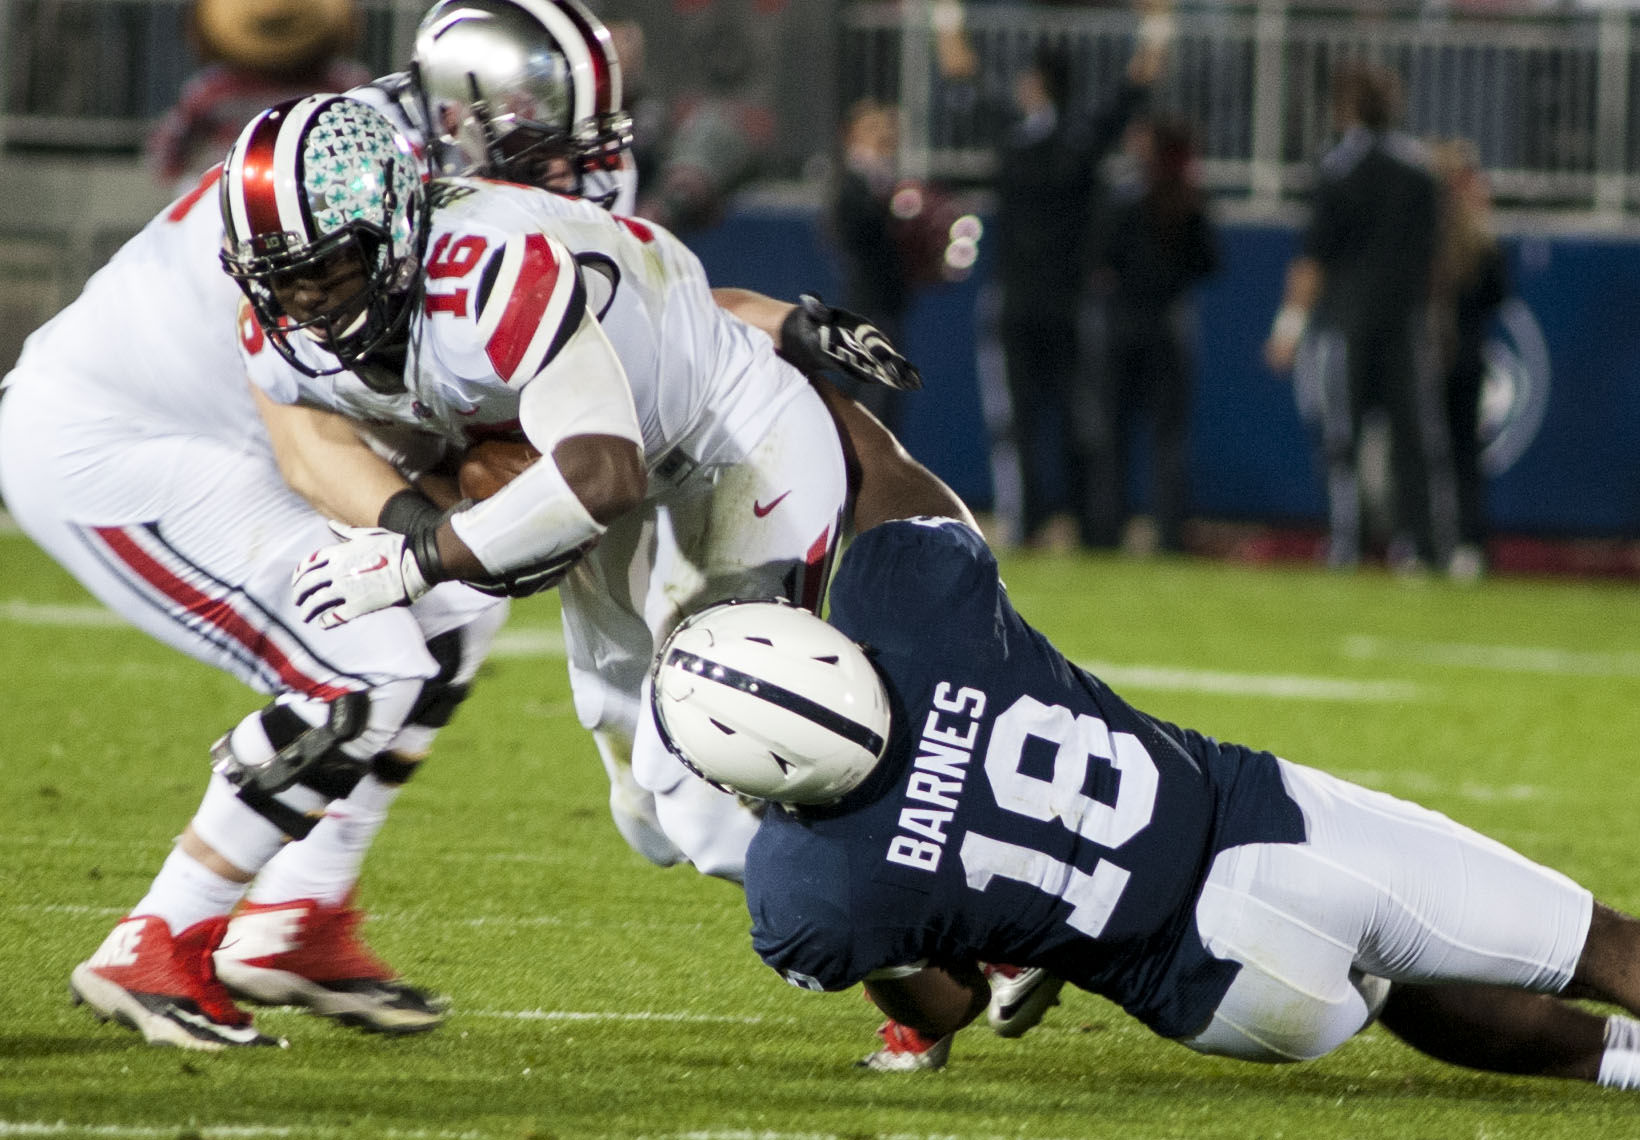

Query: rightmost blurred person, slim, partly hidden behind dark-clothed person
[[1433, 141, 1509, 581]]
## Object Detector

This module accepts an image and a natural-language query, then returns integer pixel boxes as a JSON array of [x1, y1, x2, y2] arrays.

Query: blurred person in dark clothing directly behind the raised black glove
[[828, 98, 912, 433]]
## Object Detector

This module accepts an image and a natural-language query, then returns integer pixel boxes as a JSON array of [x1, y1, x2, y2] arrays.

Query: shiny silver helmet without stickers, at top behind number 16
[[410, 0, 631, 194]]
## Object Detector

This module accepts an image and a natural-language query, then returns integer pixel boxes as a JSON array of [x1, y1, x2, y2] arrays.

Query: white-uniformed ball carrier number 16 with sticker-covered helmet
[[221, 97, 911, 879]]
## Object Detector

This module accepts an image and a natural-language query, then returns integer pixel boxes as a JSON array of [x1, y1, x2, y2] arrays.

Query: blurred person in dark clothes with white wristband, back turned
[[1264, 61, 1451, 569]]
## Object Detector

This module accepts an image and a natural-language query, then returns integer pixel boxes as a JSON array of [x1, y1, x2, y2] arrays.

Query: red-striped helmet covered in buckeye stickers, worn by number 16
[[221, 95, 426, 376]]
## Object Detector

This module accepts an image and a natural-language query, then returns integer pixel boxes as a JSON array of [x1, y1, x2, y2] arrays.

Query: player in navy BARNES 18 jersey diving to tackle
[[653, 512, 1640, 1089]]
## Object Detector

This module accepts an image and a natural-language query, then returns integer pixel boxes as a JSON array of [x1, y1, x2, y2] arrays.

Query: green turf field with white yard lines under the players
[[0, 535, 1640, 1140]]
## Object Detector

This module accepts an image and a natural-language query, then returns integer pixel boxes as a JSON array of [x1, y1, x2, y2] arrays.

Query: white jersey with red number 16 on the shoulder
[[241, 179, 807, 476]]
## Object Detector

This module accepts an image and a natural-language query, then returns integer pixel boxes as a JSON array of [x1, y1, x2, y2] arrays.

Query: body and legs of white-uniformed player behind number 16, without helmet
[[0, 0, 911, 1050]]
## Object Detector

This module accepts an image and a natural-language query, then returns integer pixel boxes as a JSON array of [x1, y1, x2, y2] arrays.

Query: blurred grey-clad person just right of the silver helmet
[[638, 18, 774, 235]]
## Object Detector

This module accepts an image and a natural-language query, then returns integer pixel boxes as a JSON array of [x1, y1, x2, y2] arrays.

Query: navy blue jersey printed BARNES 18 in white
[[746, 520, 1304, 1037]]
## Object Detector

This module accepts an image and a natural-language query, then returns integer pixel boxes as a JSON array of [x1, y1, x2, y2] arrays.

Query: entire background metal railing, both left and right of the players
[[0, 0, 1640, 225]]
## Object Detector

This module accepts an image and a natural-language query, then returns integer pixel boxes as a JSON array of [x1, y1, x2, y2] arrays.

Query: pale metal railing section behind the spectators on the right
[[840, 0, 1640, 225]]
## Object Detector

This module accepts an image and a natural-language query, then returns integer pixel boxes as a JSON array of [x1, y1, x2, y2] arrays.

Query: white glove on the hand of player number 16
[[290, 522, 431, 630]]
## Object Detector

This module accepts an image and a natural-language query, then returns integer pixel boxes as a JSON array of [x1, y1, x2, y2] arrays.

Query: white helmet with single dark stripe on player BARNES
[[651, 602, 891, 804]]
